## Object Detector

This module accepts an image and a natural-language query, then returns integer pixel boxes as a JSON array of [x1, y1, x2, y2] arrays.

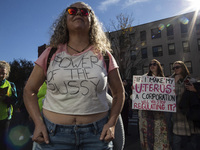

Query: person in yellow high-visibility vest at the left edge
[[0, 61, 17, 150]]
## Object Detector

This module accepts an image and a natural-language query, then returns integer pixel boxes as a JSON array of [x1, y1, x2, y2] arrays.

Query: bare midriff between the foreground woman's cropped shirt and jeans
[[43, 109, 108, 125]]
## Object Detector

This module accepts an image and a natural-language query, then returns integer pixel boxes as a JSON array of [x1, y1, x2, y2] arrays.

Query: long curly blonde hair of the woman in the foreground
[[49, 2, 111, 54]]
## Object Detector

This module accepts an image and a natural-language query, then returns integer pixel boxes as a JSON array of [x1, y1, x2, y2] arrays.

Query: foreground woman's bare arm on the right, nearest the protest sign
[[100, 69, 125, 141]]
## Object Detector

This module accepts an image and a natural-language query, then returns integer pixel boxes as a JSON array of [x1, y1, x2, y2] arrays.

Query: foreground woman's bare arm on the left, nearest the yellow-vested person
[[23, 64, 49, 143]]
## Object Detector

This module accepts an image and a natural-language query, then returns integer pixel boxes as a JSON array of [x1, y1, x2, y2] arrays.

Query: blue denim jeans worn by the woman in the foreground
[[35, 114, 113, 150]]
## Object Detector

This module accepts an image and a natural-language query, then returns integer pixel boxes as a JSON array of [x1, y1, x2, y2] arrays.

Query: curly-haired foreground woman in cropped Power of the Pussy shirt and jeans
[[24, 2, 124, 150]]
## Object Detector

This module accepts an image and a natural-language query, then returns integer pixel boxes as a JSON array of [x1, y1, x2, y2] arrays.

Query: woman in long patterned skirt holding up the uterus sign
[[138, 59, 170, 150]]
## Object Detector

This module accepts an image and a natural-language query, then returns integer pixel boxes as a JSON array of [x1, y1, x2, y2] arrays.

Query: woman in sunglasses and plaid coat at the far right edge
[[172, 61, 200, 150]]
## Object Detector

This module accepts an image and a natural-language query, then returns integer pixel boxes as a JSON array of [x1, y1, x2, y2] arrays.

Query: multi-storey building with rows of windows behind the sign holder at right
[[109, 12, 200, 79]]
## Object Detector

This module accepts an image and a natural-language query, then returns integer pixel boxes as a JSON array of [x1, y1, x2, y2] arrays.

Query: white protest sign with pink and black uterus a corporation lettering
[[132, 76, 176, 112]]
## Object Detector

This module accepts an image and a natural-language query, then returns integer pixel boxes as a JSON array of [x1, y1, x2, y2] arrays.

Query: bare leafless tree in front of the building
[[109, 13, 145, 79]]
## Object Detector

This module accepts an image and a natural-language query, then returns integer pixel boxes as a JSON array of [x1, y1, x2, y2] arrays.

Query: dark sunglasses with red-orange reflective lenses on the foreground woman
[[66, 7, 91, 16]]
